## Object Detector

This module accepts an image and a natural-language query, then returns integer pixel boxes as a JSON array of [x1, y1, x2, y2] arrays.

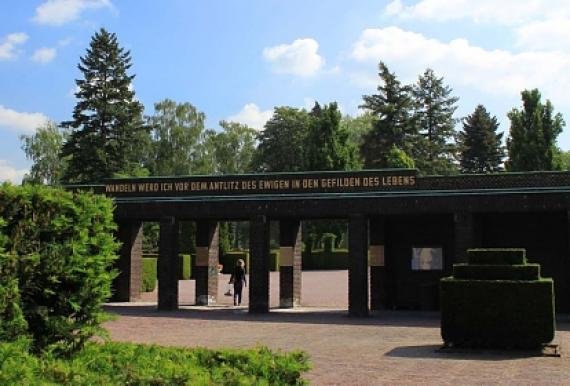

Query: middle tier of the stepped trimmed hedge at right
[[453, 264, 540, 280]]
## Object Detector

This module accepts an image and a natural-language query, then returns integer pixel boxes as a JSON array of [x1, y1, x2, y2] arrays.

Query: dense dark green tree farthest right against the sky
[[506, 89, 565, 172]]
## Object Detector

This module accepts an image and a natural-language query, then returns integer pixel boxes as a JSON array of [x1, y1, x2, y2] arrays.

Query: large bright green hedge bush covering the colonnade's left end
[[0, 183, 118, 352]]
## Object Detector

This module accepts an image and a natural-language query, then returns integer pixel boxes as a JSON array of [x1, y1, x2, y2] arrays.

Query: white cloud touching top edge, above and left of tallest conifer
[[32, 0, 113, 26]]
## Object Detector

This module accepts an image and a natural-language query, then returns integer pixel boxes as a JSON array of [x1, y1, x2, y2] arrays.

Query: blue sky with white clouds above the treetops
[[0, 0, 570, 183]]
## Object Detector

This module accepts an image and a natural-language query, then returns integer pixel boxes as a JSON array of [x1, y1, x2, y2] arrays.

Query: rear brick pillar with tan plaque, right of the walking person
[[279, 219, 301, 308]]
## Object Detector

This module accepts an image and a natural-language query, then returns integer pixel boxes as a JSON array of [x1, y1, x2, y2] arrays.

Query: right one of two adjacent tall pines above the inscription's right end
[[412, 68, 459, 175]]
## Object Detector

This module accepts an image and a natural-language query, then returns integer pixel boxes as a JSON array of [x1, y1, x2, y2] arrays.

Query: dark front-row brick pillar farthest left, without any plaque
[[158, 217, 178, 311]]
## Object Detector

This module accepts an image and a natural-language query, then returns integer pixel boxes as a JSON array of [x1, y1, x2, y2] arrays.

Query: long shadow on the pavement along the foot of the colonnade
[[105, 304, 440, 328]]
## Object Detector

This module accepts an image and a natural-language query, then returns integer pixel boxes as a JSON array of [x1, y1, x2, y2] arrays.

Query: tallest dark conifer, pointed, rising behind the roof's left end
[[61, 28, 148, 182]]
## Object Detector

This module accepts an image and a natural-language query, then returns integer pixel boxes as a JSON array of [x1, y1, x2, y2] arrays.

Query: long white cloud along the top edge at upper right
[[384, 0, 570, 25]]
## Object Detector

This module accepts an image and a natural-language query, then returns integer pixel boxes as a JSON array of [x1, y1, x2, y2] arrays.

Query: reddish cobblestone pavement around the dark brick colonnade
[[106, 271, 570, 385]]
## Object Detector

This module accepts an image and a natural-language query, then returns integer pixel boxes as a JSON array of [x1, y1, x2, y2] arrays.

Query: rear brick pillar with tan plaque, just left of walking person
[[195, 220, 216, 306]]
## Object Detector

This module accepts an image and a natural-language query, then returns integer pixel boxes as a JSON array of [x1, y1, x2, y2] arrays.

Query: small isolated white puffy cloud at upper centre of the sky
[[263, 39, 325, 77]]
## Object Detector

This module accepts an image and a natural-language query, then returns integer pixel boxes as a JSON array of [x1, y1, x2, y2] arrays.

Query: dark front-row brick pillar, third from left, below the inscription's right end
[[348, 214, 368, 316]]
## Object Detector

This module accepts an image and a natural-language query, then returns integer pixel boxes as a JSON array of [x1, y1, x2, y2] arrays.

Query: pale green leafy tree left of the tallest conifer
[[20, 121, 68, 185]]
